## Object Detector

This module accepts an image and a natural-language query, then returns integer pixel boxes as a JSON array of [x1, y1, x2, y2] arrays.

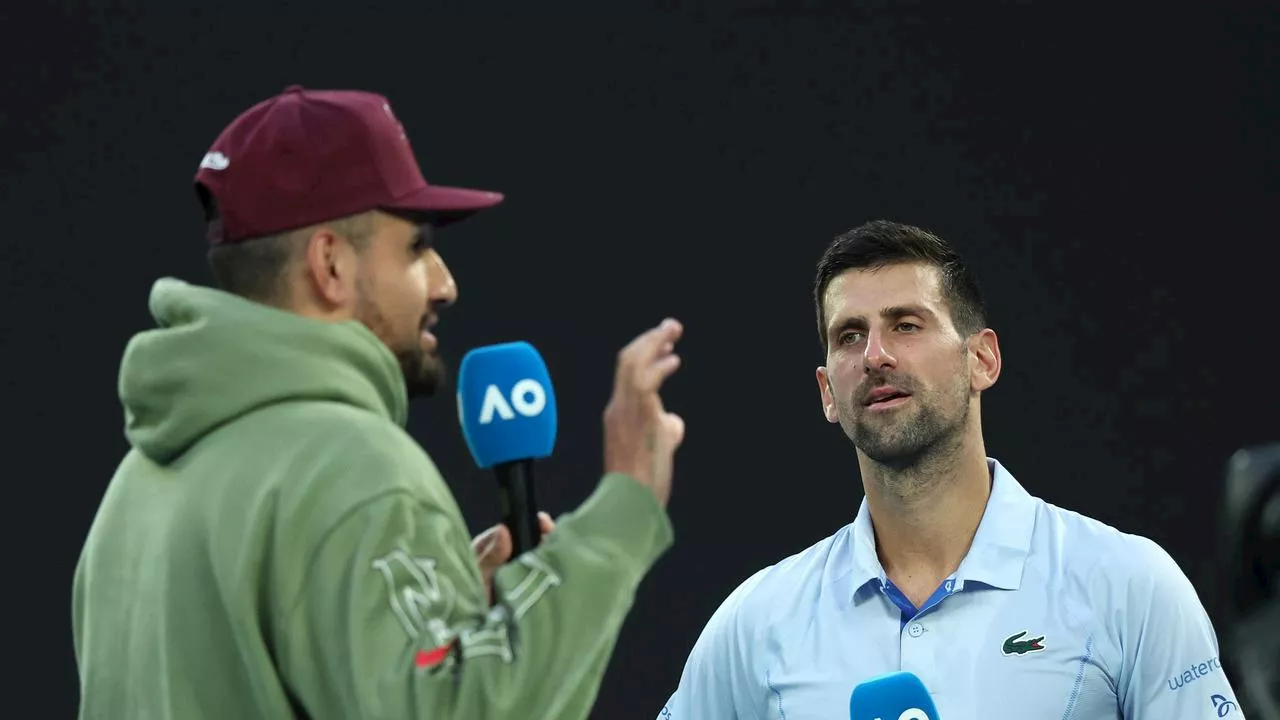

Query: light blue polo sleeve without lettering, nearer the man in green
[[658, 570, 767, 720]]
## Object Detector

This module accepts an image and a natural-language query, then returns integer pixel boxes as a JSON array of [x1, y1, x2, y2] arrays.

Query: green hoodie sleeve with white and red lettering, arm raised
[[270, 474, 672, 720]]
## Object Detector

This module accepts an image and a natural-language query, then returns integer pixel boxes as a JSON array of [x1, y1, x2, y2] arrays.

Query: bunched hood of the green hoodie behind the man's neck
[[119, 278, 408, 464]]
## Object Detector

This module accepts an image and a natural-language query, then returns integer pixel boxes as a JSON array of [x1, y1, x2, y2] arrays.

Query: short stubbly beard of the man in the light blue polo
[[838, 366, 969, 470]]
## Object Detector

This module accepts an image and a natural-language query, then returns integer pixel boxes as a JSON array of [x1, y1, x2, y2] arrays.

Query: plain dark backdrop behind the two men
[[0, 1, 1280, 720]]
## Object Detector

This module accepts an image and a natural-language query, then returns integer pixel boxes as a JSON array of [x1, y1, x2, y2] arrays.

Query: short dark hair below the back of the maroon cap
[[205, 199, 372, 305]]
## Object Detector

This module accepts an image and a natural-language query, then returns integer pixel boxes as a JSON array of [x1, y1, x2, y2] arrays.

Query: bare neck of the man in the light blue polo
[[858, 423, 991, 583]]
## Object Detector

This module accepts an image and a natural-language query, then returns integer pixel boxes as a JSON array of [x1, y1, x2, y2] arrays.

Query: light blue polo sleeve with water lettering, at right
[[1117, 538, 1244, 720]]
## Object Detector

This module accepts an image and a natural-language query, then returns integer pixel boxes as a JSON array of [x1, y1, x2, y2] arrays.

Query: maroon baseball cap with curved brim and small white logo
[[196, 85, 503, 245]]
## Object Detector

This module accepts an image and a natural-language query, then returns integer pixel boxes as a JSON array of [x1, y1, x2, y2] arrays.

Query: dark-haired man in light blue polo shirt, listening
[[658, 222, 1243, 720]]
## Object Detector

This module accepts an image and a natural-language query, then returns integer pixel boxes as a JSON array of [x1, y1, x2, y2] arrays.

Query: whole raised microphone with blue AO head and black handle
[[458, 341, 556, 557]]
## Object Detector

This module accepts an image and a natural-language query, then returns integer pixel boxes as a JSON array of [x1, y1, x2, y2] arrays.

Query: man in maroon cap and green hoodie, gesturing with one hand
[[73, 87, 684, 719]]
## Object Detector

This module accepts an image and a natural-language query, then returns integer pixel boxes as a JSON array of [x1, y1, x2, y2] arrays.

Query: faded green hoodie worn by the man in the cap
[[73, 279, 672, 720]]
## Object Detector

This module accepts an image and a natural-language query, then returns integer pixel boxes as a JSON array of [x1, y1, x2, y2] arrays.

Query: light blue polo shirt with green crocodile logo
[[658, 459, 1243, 720]]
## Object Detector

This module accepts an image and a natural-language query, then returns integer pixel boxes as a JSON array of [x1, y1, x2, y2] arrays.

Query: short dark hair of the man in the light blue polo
[[813, 220, 987, 348]]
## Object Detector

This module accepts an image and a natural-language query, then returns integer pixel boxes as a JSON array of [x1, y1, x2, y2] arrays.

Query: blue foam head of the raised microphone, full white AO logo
[[458, 341, 556, 468]]
